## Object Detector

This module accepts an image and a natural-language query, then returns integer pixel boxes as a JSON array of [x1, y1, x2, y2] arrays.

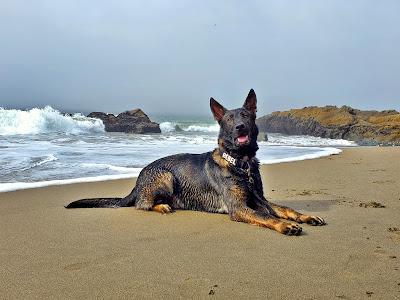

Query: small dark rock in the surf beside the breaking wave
[[88, 108, 161, 133]]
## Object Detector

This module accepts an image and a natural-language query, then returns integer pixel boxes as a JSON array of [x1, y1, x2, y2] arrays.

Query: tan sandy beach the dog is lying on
[[0, 148, 400, 299]]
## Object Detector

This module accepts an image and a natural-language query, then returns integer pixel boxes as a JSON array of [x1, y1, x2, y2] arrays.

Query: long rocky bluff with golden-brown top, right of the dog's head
[[257, 106, 400, 145]]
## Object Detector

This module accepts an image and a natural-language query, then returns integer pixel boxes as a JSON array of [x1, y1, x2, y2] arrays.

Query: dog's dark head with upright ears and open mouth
[[210, 89, 258, 156]]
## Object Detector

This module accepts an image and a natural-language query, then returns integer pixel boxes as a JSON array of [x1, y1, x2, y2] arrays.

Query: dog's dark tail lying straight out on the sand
[[65, 193, 136, 208]]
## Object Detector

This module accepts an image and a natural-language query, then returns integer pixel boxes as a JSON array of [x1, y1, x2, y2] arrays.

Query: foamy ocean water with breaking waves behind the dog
[[0, 106, 356, 192]]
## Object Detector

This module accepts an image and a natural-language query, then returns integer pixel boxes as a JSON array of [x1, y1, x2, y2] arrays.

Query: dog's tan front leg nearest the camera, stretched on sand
[[230, 207, 302, 235]]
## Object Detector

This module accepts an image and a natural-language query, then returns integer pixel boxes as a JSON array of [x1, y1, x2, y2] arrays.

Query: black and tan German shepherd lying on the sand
[[66, 90, 325, 235]]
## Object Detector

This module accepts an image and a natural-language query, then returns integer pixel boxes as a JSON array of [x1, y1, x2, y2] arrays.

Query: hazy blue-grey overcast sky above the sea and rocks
[[0, 0, 400, 115]]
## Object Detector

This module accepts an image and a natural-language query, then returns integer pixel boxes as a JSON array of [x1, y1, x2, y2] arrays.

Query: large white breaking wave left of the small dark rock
[[0, 106, 104, 135]]
